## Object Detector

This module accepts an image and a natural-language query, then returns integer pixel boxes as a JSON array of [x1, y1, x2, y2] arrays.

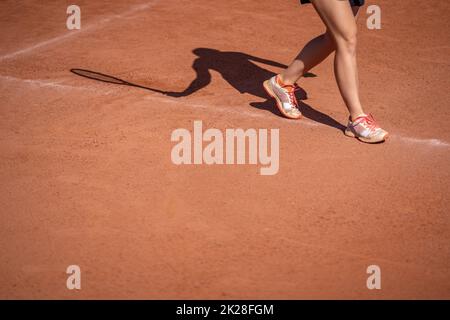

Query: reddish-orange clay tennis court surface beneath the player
[[0, 0, 450, 299]]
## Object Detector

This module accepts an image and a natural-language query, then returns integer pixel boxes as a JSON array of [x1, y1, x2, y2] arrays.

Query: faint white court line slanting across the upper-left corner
[[0, 0, 157, 61]]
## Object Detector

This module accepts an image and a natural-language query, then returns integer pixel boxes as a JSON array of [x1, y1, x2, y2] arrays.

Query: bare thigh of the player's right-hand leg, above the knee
[[311, 0, 358, 41]]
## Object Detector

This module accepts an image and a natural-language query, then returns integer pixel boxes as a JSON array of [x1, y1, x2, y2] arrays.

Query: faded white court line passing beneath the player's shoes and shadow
[[0, 75, 450, 148]]
